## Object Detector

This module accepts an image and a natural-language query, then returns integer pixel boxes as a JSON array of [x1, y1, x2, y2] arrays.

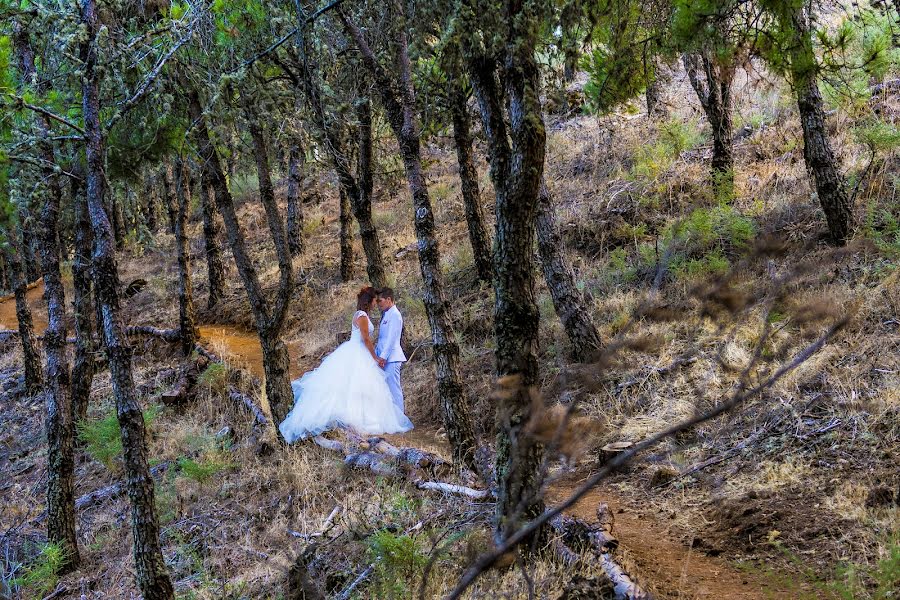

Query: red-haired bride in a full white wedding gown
[[278, 287, 413, 443]]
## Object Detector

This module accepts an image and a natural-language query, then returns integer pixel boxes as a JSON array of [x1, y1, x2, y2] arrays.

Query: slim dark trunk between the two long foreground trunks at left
[[72, 179, 94, 423]]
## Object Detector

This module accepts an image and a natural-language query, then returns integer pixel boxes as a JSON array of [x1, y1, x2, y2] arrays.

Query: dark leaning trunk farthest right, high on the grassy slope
[[785, 7, 854, 246]]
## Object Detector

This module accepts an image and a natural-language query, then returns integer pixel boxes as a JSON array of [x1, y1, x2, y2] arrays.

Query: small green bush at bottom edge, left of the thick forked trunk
[[367, 530, 428, 598]]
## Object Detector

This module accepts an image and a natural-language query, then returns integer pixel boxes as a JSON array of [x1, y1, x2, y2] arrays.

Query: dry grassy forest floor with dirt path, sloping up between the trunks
[[0, 69, 900, 598]]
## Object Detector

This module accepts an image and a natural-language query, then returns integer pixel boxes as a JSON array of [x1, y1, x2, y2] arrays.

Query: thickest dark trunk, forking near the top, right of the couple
[[468, 14, 546, 539]]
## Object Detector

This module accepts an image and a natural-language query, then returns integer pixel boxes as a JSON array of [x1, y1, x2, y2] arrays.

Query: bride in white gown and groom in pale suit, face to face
[[278, 287, 413, 443]]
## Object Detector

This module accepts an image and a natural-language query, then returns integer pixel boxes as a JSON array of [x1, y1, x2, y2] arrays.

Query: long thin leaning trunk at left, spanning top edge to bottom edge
[[81, 0, 174, 600]]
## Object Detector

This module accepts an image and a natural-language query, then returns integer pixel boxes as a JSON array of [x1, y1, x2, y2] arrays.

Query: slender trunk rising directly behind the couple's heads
[[351, 98, 387, 288]]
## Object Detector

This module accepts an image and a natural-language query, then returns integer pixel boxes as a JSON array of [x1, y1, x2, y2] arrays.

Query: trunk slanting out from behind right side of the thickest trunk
[[537, 183, 601, 361]]
